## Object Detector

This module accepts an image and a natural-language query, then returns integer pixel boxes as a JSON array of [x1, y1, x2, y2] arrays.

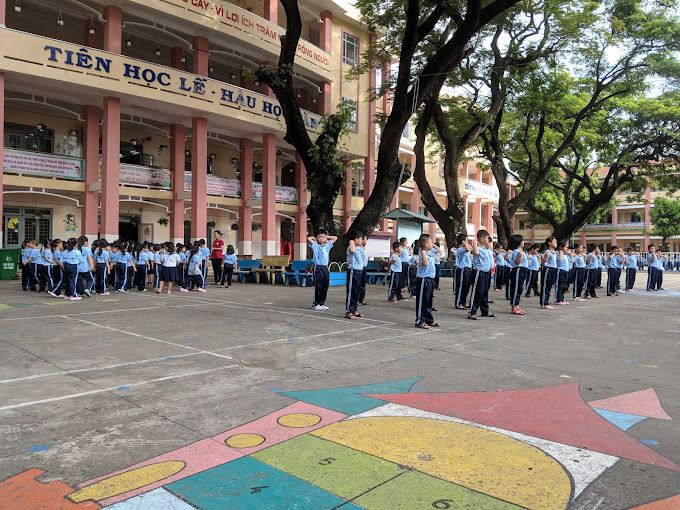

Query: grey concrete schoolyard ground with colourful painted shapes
[[0, 273, 680, 510]]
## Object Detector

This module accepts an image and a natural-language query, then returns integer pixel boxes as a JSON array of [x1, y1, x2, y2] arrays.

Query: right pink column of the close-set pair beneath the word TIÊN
[[100, 97, 120, 241]]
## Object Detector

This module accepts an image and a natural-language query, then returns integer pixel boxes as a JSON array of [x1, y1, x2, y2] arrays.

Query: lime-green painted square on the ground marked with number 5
[[251, 435, 404, 499]]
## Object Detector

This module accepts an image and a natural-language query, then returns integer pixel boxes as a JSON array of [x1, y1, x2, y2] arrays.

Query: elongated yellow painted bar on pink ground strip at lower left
[[68, 460, 186, 503]]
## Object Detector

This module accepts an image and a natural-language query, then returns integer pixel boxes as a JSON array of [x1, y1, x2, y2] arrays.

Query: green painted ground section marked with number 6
[[352, 471, 522, 510]]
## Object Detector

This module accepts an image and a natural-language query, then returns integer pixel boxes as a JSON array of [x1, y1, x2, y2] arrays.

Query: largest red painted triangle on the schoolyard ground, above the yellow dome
[[368, 383, 680, 471]]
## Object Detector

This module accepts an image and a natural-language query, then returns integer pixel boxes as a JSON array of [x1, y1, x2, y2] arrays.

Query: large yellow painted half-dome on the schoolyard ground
[[311, 416, 571, 510]]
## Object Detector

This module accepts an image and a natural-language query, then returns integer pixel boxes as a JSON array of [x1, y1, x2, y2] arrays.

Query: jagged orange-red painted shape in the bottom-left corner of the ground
[[0, 469, 100, 510]]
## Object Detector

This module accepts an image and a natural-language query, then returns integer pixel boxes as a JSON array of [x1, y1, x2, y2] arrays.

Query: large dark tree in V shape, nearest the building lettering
[[256, 0, 519, 242]]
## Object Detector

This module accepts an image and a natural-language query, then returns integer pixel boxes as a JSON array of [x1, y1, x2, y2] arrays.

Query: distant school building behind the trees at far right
[[514, 188, 680, 252]]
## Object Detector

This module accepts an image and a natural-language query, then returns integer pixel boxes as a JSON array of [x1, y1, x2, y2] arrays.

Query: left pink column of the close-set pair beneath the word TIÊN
[[80, 105, 100, 242]]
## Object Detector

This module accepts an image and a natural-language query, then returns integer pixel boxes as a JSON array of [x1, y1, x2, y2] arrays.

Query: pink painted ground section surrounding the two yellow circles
[[213, 402, 347, 455]]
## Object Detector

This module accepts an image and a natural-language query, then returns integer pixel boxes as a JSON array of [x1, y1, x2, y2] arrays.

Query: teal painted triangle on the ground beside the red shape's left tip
[[278, 377, 420, 416]]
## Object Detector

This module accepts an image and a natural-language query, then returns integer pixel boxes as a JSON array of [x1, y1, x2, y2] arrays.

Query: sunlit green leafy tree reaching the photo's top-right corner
[[482, 0, 680, 244]]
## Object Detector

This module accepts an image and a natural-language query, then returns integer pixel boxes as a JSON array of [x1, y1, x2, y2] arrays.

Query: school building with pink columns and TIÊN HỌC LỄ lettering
[[0, 0, 497, 258]]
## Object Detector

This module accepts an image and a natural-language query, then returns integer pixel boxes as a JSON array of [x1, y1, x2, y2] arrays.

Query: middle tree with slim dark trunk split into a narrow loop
[[414, 0, 590, 246]]
